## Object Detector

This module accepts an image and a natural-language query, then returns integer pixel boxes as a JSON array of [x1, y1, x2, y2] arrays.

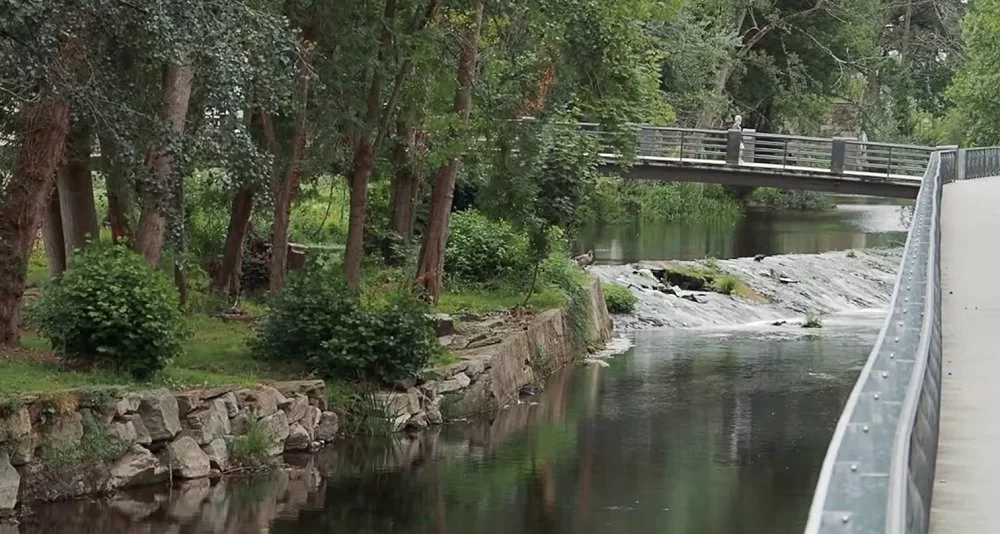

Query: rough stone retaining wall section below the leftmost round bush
[[0, 380, 338, 513]]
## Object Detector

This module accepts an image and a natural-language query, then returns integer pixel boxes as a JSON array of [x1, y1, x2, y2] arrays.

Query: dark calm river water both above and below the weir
[[13, 200, 905, 534]]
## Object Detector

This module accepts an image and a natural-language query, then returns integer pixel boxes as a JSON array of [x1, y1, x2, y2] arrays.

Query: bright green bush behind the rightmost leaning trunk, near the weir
[[444, 210, 527, 286]]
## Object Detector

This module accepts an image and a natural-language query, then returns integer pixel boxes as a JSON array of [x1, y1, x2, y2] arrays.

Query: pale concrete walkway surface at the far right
[[931, 177, 1000, 534]]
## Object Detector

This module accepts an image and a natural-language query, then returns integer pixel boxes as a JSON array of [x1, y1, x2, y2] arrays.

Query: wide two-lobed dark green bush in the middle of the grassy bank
[[252, 260, 441, 381]]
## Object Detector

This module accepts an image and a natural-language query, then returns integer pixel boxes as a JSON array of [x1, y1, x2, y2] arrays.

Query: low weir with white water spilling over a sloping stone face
[[590, 248, 902, 330]]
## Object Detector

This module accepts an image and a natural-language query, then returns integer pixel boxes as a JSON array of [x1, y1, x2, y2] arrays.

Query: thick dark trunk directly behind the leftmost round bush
[[56, 123, 99, 262]]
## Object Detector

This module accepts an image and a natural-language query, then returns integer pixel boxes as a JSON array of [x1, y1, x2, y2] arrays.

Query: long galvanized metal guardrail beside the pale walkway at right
[[805, 147, 1000, 534]]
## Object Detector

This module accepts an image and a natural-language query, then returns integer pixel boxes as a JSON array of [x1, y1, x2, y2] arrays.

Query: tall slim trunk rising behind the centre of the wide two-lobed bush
[[344, 0, 396, 289]]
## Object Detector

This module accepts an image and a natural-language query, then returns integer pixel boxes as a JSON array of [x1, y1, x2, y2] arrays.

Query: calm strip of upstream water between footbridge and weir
[[579, 203, 907, 264]]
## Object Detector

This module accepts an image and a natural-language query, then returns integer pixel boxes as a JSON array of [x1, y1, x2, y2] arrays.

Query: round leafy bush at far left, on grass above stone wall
[[31, 244, 185, 378]]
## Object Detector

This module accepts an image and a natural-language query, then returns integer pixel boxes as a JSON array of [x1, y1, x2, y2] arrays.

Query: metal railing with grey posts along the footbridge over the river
[[579, 123, 935, 178]]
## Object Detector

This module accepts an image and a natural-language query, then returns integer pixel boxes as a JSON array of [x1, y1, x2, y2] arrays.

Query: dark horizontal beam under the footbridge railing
[[598, 163, 920, 199]]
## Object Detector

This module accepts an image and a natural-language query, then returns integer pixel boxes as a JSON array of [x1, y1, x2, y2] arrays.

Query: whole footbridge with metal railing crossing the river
[[581, 124, 955, 198]]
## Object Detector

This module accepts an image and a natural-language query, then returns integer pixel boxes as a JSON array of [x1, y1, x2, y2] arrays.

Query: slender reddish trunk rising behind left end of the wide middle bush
[[261, 25, 316, 292]]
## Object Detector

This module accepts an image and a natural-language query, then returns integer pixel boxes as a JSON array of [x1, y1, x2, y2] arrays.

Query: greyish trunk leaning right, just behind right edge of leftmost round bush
[[135, 59, 194, 265]]
